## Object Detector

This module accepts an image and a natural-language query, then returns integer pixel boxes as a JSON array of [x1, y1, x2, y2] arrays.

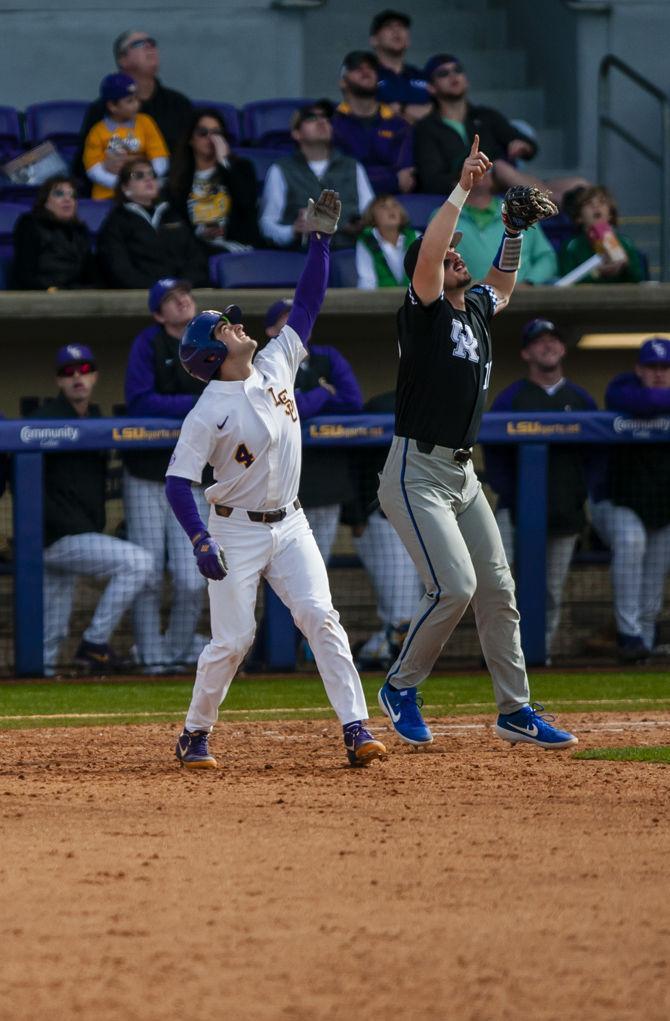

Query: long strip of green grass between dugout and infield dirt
[[0, 673, 670, 729]]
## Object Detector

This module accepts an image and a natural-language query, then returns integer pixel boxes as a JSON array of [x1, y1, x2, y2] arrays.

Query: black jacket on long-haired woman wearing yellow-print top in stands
[[168, 155, 261, 254]]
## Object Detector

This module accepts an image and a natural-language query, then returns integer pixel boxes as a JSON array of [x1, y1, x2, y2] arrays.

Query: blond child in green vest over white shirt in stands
[[355, 195, 418, 291]]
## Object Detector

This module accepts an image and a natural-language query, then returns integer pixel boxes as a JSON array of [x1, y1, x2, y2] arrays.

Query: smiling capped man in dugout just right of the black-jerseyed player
[[484, 319, 599, 657]]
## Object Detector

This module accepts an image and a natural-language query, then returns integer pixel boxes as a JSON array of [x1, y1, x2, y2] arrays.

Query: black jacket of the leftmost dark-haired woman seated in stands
[[13, 209, 98, 291]]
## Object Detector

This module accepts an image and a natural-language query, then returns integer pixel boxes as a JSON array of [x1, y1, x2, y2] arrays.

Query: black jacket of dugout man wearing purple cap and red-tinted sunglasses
[[29, 393, 107, 546]]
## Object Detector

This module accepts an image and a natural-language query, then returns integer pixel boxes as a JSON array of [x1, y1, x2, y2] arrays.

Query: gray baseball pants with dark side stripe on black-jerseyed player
[[379, 436, 529, 713]]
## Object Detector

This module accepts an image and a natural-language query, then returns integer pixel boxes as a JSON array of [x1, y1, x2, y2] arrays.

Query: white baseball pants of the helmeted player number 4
[[186, 506, 368, 730]]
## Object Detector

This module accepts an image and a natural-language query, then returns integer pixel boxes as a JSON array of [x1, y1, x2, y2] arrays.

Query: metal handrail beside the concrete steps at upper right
[[597, 53, 670, 281]]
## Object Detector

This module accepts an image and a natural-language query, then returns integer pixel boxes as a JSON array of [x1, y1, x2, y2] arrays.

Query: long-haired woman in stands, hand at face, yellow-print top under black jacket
[[168, 109, 260, 254]]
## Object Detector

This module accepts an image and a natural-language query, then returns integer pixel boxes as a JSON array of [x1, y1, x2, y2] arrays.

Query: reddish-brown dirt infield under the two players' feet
[[0, 714, 670, 1021]]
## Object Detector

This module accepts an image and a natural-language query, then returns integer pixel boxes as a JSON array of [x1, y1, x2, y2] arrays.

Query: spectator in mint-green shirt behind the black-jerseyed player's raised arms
[[459, 174, 559, 284]]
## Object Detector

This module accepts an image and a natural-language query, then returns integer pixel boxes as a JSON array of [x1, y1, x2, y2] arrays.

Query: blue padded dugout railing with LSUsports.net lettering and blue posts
[[0, 411, 670, 677]]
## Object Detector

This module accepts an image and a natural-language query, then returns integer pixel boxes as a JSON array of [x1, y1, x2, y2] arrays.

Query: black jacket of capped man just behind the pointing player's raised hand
[[414, 103, 537, 195]]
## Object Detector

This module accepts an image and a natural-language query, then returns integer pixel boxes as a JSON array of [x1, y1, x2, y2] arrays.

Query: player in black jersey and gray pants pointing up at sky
[[379, 137, 577, 748]]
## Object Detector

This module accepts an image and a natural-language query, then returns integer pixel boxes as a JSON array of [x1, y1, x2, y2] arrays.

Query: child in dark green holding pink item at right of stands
[[559, 185, 645, 284]]
